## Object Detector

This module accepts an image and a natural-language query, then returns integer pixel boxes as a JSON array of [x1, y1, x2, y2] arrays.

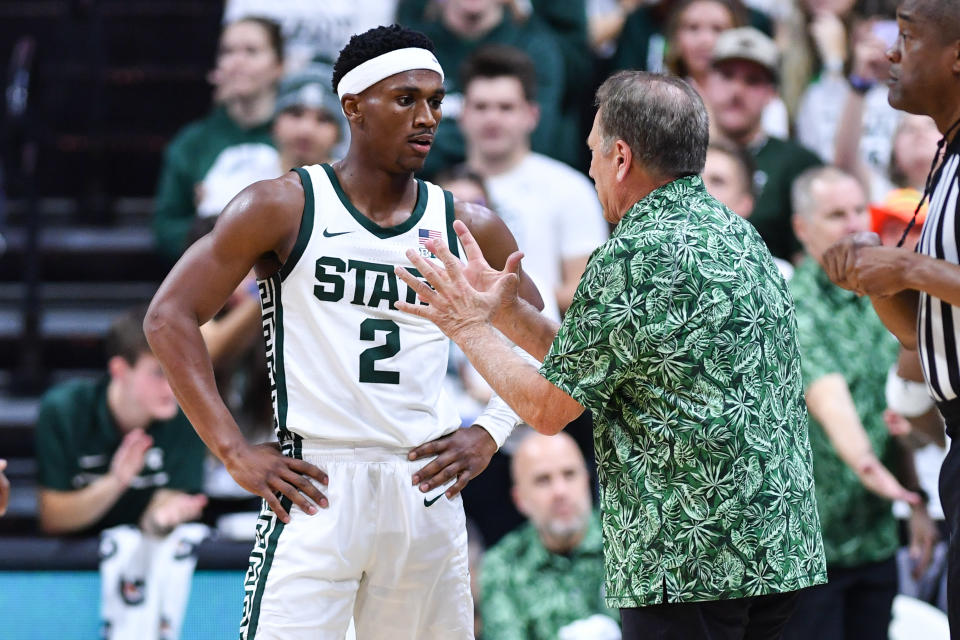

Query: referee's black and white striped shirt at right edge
[[917, 136, 960, 402]]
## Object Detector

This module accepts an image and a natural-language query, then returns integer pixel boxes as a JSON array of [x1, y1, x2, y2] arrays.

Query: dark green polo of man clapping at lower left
[[34, 377, 206, 535]]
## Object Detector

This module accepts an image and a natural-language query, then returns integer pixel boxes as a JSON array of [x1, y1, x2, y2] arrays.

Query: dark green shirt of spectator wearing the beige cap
[[750, 138, 823, 260]]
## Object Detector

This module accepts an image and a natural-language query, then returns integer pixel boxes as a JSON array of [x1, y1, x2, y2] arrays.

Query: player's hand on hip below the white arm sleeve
[[409, 425, 497, 499]]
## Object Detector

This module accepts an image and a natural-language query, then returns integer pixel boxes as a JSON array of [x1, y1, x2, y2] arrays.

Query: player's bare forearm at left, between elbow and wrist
[[143, 296, 246, 461]]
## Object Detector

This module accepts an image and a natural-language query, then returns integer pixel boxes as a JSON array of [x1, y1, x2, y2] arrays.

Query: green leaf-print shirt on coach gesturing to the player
[[541, 176, 826, 607]]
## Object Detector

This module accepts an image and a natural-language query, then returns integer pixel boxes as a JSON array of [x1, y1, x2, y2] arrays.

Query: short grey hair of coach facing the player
[[596, 71, 710, 178]]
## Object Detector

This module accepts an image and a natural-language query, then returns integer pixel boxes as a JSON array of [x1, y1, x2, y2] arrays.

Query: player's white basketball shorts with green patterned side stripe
[[234, 441, 473, 640]]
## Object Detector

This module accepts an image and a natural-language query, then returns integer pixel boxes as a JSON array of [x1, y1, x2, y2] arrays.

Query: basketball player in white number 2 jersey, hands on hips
[[145, 26, 542, 640]]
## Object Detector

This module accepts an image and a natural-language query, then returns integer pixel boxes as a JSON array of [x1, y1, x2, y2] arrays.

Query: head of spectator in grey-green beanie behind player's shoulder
[[273, 65, 349, 171]]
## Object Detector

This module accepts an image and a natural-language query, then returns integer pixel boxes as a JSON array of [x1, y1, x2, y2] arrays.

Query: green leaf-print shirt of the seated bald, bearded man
[[480, 514, 619, 640]]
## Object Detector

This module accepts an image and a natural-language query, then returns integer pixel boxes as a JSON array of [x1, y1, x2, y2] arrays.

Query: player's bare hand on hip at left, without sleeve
[[224, 443, 328, 523]]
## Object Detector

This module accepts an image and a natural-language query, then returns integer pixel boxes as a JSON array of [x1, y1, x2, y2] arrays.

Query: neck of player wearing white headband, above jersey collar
[[333, 156, 417, 226]]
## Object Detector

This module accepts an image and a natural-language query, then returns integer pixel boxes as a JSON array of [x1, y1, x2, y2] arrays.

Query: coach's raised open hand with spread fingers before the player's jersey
[[395, 232, 519, 341]]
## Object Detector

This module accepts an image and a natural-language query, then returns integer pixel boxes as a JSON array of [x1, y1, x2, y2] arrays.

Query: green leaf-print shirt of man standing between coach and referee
[[790, 258, 899, 567]]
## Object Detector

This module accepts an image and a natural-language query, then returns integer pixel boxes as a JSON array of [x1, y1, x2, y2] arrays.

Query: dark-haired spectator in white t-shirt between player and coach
[[460, 45, 607, 312]]
